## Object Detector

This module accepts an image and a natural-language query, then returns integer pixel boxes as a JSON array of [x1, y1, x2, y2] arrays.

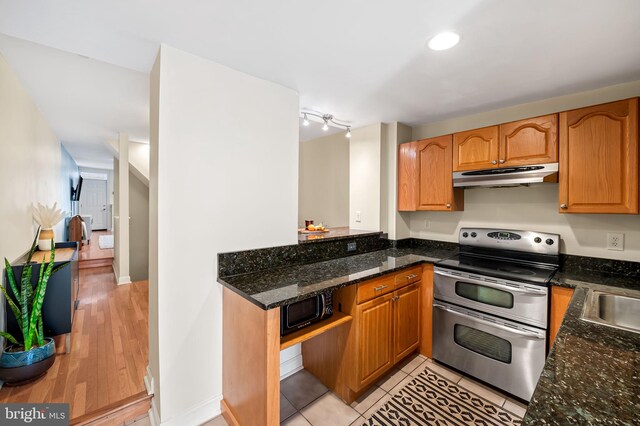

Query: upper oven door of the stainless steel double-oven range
[[433, 266, 548, 328]]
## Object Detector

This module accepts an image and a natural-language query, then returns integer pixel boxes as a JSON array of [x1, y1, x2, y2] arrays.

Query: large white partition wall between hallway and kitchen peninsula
[[147, 45, 299, 425]]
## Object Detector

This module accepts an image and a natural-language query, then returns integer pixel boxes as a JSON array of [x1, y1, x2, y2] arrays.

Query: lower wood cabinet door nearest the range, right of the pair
[[393, 283, 420, 361]]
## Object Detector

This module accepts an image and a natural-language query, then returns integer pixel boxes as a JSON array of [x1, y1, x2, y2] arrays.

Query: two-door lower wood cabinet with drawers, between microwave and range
[[302, 265, 433, 404]]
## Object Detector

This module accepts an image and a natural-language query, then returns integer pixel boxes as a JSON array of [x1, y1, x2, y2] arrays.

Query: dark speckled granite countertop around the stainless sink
[[523, 284, 640, 425]]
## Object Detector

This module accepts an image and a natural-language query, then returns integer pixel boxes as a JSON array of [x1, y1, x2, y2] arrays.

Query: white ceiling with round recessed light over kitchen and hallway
[[0, 0, 640, 165]]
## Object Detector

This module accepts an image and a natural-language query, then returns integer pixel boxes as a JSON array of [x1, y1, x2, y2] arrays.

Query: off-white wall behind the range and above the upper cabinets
[[408, 81, 640, 261]]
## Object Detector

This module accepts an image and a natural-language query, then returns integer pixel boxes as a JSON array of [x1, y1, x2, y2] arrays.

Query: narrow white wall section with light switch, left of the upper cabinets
[[349, 123, 386, 231]]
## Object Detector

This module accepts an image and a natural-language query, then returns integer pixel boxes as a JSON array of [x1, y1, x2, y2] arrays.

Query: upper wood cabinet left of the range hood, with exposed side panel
[[398, 135, 464, 211]]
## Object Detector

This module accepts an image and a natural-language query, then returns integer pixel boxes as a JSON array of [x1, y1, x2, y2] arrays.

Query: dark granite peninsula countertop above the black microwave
[[218, 248, 456, 309]]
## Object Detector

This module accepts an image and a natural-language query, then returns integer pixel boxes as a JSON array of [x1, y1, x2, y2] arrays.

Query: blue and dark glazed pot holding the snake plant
[[0, 338, 56, 386]]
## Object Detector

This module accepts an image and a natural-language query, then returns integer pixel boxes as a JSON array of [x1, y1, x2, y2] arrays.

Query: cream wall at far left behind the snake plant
[[0, 51, 62, 261]]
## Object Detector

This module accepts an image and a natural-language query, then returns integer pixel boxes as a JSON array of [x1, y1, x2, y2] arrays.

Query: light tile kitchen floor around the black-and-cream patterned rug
[[202, 355, 526, 426]]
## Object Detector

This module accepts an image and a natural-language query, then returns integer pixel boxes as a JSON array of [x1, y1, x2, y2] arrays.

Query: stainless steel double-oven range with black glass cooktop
[[433, 228, 560, 401]]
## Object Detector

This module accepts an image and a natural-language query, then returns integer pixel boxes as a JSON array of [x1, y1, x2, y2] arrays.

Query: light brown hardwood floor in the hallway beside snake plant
[[0, 266, 149, 419]]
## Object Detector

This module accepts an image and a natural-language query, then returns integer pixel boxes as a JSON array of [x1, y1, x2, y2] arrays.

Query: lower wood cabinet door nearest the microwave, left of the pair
[[357, 293, 393, 390]]
